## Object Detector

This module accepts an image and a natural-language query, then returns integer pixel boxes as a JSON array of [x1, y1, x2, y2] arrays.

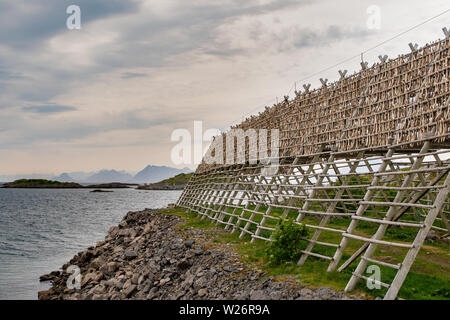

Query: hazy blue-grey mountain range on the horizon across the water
[[0, 165, 192, 183]]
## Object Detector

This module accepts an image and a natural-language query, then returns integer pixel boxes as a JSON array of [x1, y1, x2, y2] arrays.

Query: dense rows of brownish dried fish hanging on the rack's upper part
[[197, 39, 450, 172]]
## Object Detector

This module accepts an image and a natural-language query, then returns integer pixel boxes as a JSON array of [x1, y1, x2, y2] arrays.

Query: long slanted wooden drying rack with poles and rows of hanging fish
[[177, 37, 450, 299]]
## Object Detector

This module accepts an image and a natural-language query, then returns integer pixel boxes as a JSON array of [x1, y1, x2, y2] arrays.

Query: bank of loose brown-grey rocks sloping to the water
[[38, 209, 351, 300]]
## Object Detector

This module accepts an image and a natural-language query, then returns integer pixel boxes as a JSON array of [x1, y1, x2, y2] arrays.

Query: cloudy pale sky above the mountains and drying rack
[[0, 0, 450, 175]]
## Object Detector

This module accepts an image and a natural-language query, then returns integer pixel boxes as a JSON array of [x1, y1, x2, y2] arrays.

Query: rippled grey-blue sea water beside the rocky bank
[[0, 188, 181, 299]]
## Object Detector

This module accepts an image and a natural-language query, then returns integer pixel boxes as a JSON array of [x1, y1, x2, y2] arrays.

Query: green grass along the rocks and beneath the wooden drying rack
[[163, 207, 450, 300]]
